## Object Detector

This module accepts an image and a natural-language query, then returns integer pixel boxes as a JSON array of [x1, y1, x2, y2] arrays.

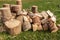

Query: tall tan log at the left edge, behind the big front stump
[[0, 8, 12, 22]]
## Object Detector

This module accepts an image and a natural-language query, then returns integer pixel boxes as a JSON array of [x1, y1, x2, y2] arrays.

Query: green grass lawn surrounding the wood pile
[[0, 0, 60, 40]]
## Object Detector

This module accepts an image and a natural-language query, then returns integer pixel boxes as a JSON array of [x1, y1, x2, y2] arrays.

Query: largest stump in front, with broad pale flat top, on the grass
[[5, 19, 21, 35]]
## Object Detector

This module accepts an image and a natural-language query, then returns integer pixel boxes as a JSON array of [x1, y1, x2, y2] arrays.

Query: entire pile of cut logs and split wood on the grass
[[0, 0, 60, 35]]
